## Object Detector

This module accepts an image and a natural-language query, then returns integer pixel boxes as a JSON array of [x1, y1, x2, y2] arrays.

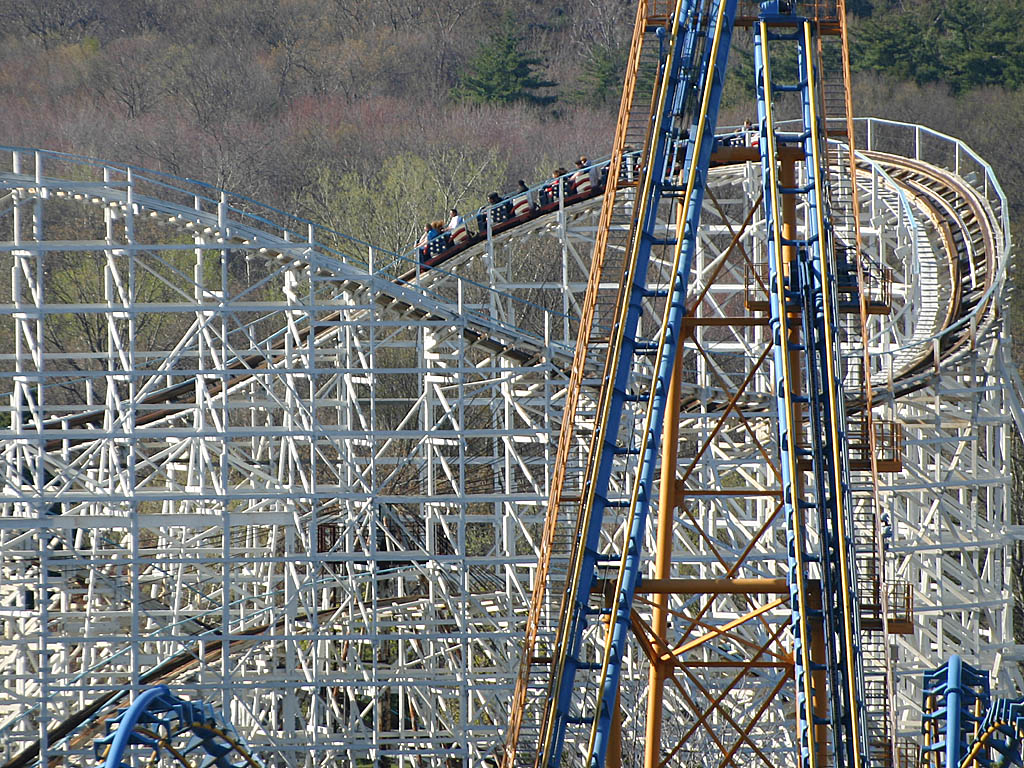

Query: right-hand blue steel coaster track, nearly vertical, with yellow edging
[[754, 10, 866, 768]]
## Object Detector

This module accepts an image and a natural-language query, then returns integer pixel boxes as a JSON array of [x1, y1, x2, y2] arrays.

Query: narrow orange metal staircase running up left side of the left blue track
[[502, 0, 670, 768]]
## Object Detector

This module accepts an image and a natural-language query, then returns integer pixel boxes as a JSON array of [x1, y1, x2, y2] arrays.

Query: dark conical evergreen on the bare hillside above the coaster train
[[453, 23, 556, 104]]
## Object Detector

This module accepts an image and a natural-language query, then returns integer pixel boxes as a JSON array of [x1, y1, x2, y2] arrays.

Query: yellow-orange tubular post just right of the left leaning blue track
[[644, 340, 683, 768]]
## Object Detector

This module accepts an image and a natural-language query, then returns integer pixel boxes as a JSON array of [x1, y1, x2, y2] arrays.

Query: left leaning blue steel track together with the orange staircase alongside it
[[505, 0, 735, 766]]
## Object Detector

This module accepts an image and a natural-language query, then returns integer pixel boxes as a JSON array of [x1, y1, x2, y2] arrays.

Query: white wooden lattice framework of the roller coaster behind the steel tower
[[0, 115, 1019, 766]]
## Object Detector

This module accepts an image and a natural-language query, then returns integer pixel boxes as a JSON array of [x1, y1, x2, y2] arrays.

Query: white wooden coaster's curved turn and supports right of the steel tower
[[857, 120, 1024, 749]]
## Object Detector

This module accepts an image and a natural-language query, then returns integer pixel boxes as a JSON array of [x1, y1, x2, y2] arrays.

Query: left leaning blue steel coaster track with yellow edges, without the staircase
[[538, 0, 736, 768]]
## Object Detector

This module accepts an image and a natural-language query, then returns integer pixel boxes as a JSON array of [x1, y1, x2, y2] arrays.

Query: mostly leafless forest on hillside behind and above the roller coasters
[[0, 0, 1024, 249]]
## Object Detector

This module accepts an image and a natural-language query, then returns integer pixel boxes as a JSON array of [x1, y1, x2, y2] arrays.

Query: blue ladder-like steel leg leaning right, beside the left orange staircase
[[542, 0, 736, 768]]
